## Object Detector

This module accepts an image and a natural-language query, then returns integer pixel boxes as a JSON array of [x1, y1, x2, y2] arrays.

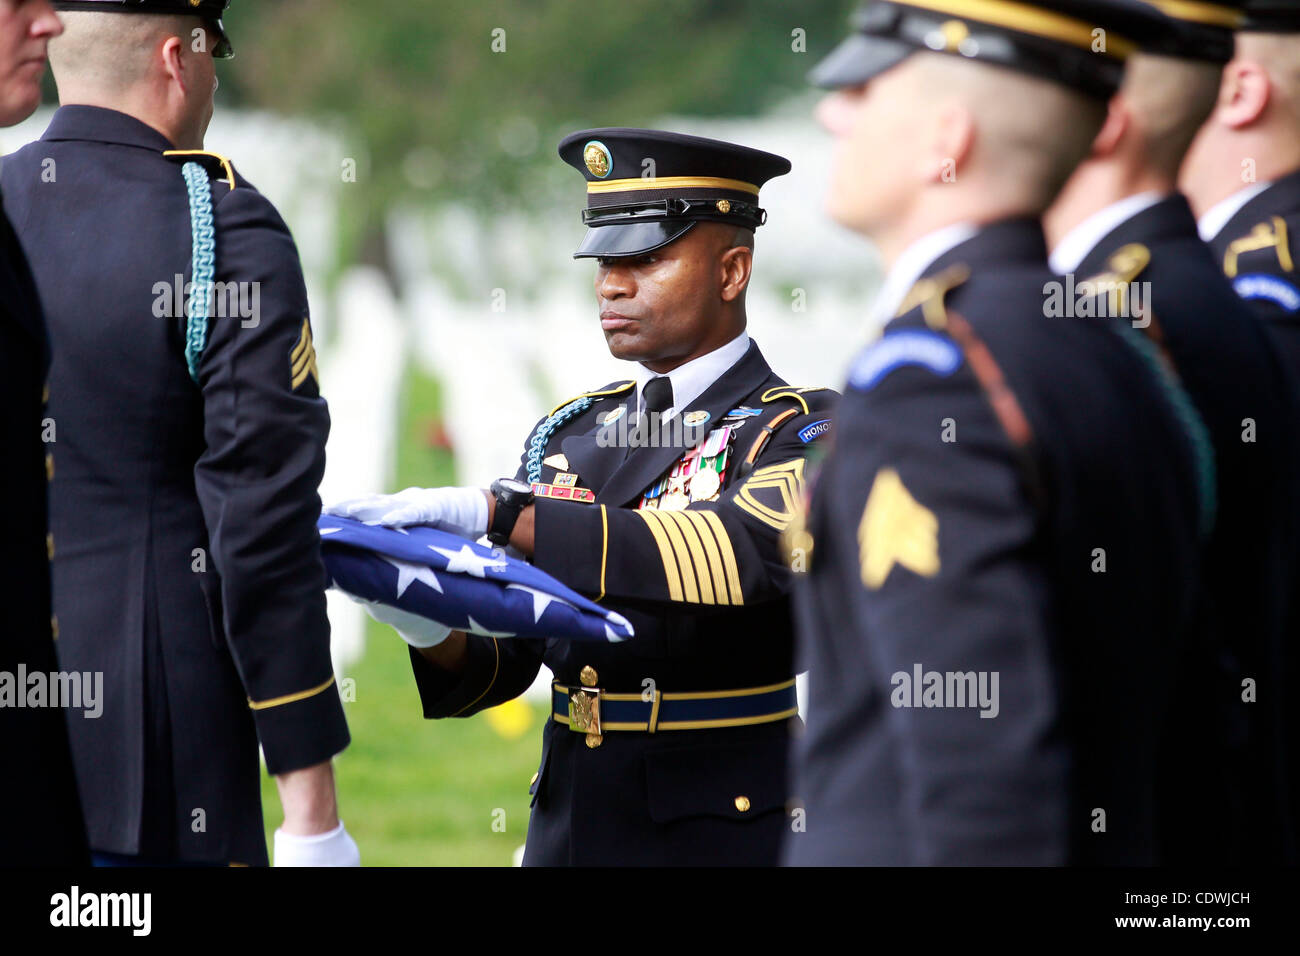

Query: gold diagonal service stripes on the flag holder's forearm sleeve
[[632, 509, 745, 605]]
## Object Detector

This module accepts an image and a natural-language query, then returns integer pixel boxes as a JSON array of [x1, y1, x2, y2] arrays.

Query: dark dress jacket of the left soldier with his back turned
[[4, 107, 348, 864]]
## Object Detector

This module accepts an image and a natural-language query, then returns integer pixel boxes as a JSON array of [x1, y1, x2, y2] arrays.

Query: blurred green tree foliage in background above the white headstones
[[222, 0, 854, 269]]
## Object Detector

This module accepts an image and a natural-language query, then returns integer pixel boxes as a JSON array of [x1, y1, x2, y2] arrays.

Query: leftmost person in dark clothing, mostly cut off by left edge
[[0, 0, 88, 866]]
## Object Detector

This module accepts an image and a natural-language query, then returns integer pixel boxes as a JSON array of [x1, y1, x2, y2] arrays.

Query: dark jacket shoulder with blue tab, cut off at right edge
[[1210, 169, 1300, 375]]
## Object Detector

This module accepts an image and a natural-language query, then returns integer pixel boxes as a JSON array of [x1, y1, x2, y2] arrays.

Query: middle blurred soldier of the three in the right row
[[1044, 4, 1300, 865]]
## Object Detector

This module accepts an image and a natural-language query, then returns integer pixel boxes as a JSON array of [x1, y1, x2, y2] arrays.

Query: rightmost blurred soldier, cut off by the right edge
[[1180, 0, 1300, 373]]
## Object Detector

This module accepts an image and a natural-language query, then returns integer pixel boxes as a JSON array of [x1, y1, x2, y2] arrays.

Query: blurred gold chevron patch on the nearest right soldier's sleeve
[[858, 468, 939, 591]]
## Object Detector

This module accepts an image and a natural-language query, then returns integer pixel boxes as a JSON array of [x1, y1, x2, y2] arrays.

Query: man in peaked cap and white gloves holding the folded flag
[[330, 129, 835, 865]]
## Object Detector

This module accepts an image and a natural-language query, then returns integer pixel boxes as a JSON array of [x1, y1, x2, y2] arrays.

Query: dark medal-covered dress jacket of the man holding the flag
[[411, 343, 836, 865]]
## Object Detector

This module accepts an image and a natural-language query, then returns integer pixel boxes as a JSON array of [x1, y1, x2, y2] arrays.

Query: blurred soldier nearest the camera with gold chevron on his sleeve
[[787, 0, 1213, 865]]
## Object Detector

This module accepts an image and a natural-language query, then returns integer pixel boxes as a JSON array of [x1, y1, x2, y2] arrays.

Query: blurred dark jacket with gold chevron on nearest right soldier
[[785, 220, 1204, 865]]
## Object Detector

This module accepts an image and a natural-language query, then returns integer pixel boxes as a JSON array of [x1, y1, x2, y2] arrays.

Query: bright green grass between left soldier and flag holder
[[263, 368, 546, 866]]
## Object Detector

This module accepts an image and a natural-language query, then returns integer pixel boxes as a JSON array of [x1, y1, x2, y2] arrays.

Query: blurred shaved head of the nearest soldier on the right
[[818, 52, 1105, 263]]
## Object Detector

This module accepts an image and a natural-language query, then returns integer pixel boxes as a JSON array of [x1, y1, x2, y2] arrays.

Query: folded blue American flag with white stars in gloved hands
[[316, 515, 632, 641]]
